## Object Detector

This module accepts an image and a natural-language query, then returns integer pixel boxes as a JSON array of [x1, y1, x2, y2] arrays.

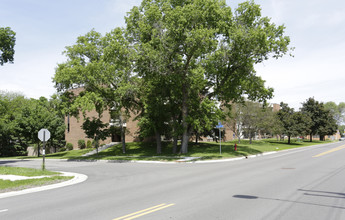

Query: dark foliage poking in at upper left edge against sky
[[0, 27, 16, 66]]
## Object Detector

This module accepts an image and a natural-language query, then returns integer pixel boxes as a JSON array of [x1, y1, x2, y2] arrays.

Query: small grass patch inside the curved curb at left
[[0, 167, 73, 193]]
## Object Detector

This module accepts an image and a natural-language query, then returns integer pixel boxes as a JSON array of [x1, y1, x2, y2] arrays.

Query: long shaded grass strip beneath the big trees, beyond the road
[[23, 139, 328, 161]]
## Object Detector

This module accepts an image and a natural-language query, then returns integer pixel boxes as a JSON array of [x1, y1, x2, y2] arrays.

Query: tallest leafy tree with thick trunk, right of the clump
[[126, 0, 290, 153]]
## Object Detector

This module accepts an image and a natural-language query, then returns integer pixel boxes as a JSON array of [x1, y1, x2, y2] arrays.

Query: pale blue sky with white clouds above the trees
[[0, 0, 345, 110]]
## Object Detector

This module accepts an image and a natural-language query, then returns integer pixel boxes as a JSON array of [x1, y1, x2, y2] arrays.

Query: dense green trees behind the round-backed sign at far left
[[0, 92, 65, 156]]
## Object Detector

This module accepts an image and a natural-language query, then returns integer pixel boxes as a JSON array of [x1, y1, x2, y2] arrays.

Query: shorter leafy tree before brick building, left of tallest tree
[[53, 28, 136, 152]]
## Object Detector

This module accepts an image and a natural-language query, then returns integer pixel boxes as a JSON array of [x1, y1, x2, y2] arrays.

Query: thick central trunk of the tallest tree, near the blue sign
[[181, 85, 189, 154]]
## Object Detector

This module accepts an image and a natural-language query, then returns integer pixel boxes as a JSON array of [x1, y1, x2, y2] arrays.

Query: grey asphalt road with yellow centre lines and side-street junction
[[0, 142, 345, 220]]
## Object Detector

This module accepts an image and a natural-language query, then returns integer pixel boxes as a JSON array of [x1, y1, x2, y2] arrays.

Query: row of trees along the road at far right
[[227, 98, 338, 144]]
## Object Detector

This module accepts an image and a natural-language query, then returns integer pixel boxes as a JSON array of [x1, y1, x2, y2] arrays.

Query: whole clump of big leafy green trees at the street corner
[[54, 0, 290, 153]]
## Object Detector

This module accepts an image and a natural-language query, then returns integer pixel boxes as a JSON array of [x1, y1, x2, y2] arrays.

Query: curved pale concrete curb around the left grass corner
[[0, 171, 87, 199]]
